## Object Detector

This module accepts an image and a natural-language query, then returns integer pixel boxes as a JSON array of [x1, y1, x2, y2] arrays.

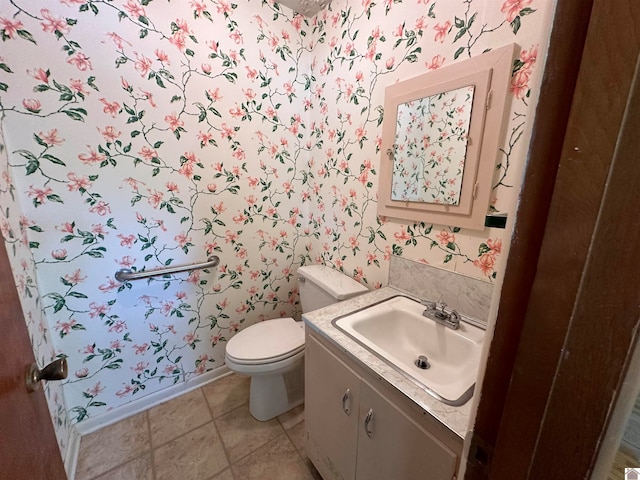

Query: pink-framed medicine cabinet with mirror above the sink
[[378, 44, 516, 230]]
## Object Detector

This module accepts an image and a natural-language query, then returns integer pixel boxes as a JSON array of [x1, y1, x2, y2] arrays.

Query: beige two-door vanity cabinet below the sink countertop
[[305, 329, 462, 480]]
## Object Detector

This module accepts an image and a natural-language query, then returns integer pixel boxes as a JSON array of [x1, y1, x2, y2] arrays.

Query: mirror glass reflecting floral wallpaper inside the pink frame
[[387, 85, 475, 205]]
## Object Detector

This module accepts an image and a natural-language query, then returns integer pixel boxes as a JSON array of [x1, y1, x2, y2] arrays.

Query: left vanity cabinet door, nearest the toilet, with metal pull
[[305, 335, 360, 480]]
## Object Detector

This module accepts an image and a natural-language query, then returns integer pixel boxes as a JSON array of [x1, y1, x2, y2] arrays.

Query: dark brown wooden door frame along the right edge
[[465, 0, 640, 479]]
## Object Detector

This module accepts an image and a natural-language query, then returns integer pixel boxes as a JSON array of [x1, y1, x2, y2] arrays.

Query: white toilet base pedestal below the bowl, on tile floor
[[249, 357, 304, 422]]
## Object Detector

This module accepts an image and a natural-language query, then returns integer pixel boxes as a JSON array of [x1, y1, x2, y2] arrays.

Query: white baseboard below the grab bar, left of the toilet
[[74, 365, 231, 436]]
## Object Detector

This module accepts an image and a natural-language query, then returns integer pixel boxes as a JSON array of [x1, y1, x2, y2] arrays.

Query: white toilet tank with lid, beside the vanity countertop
[[298, 265, 369, 313]]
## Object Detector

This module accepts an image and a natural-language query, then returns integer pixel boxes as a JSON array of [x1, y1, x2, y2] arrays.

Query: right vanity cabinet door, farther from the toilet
[[356, 382, 457, 480]]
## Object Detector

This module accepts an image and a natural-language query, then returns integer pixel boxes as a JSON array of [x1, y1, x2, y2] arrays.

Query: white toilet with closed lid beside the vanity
[[225, 265, 369, 421]]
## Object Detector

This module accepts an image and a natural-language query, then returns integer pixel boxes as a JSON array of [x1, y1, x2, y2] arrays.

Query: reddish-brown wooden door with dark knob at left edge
[[0, 237, 67, 480]]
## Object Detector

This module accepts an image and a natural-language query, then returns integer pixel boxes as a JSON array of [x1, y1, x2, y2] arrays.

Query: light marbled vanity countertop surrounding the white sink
[[302, 287, 472, 439]]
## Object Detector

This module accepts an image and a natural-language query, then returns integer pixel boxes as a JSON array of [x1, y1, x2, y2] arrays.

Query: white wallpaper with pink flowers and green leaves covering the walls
[[0, 0, 553, 460]]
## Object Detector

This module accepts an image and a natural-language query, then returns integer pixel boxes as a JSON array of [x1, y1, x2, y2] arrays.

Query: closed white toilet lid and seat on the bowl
[[225, 318, 304, 365]]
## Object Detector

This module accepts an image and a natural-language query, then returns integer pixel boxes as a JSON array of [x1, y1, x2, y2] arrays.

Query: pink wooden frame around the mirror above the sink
[[378, 44, 517, 230]]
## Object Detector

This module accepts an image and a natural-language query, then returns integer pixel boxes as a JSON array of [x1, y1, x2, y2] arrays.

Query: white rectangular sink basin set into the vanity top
[[332, 296, 484, 405]]
